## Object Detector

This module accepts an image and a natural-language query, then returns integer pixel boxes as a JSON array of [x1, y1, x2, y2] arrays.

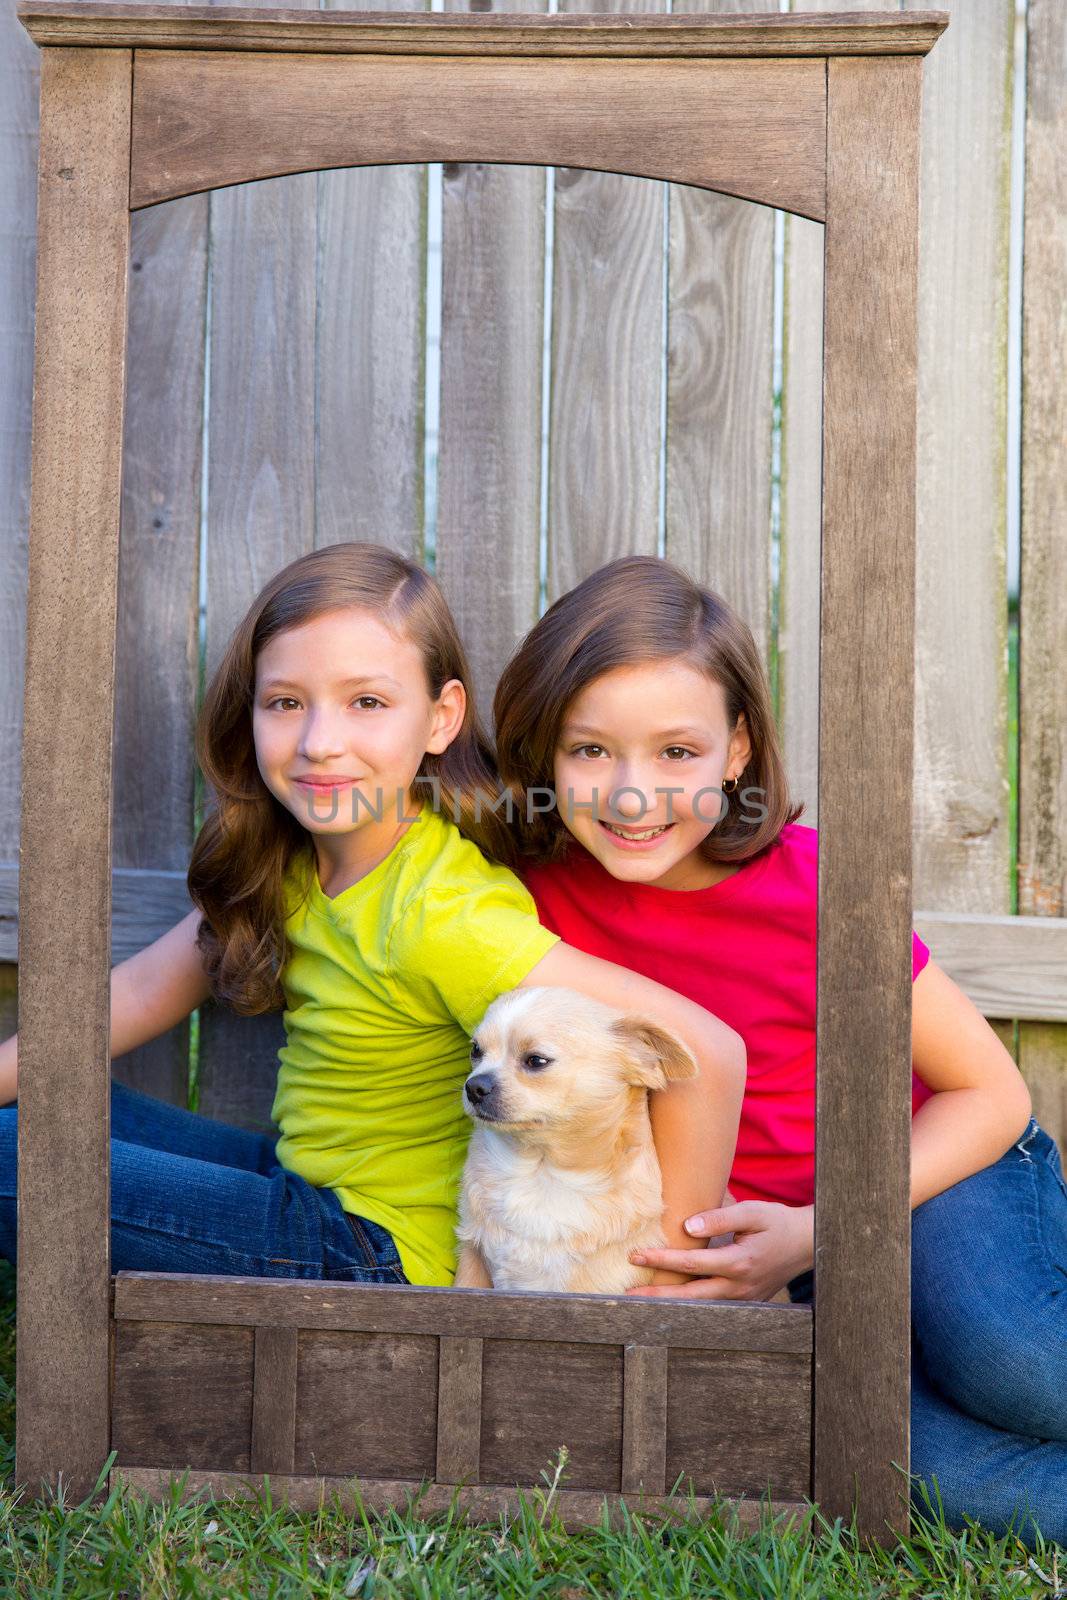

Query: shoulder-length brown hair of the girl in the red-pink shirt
[[493, 555, 803, 864]]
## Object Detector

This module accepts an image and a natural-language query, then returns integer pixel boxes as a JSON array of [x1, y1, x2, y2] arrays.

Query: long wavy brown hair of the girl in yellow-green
[[187, 542, 515, 1016]]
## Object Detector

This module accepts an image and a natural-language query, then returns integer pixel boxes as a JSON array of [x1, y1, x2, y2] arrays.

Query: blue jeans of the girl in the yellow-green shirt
[[0, 1080, 406, 1283]]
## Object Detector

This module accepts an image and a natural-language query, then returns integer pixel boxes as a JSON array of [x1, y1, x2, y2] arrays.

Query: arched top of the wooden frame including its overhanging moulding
[[19, 0, 947, 222]]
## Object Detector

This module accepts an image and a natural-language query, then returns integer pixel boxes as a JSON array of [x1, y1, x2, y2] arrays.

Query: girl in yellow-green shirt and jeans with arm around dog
[[0, 542, 744, 1283]]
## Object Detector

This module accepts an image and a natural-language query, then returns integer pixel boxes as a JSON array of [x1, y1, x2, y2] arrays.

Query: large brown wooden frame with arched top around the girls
[[16, 0, 947, 1538]]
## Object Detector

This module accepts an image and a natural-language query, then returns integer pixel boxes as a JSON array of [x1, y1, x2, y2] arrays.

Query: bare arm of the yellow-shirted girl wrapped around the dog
[[520, 944, 745, 1283]]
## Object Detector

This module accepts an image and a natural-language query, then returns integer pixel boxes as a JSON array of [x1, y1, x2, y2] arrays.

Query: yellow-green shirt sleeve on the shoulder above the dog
[[389, 872, 560, 1034]]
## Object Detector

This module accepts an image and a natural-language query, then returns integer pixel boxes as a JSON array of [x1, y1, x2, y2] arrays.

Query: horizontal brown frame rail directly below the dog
[[114, 1272, 811, 1355]]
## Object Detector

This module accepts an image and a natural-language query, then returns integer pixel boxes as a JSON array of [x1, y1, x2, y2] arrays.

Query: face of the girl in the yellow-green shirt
[[253, 606, 466, 858]]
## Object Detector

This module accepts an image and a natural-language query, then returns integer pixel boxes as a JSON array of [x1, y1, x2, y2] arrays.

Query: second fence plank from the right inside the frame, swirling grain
[[665, 0, 777, 659]]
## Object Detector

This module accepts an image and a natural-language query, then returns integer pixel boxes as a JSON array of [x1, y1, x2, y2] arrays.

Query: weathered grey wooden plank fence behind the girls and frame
[[0, 0, 1067, 1149]]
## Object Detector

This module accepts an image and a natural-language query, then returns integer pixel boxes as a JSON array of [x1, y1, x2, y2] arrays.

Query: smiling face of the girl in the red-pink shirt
[[553, 659, 750, 890]]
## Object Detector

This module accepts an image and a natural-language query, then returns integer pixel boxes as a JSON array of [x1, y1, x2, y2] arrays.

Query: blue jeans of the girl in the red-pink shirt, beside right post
[[789, 1117, 1067, 1549]]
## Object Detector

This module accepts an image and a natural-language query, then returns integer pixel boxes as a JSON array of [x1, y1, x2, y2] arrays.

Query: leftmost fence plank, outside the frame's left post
[[0, 5, 40, 1075]]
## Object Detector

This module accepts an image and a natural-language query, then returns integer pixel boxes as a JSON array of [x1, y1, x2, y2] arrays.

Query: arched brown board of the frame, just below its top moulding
[[131, 50, 824, 216]]
